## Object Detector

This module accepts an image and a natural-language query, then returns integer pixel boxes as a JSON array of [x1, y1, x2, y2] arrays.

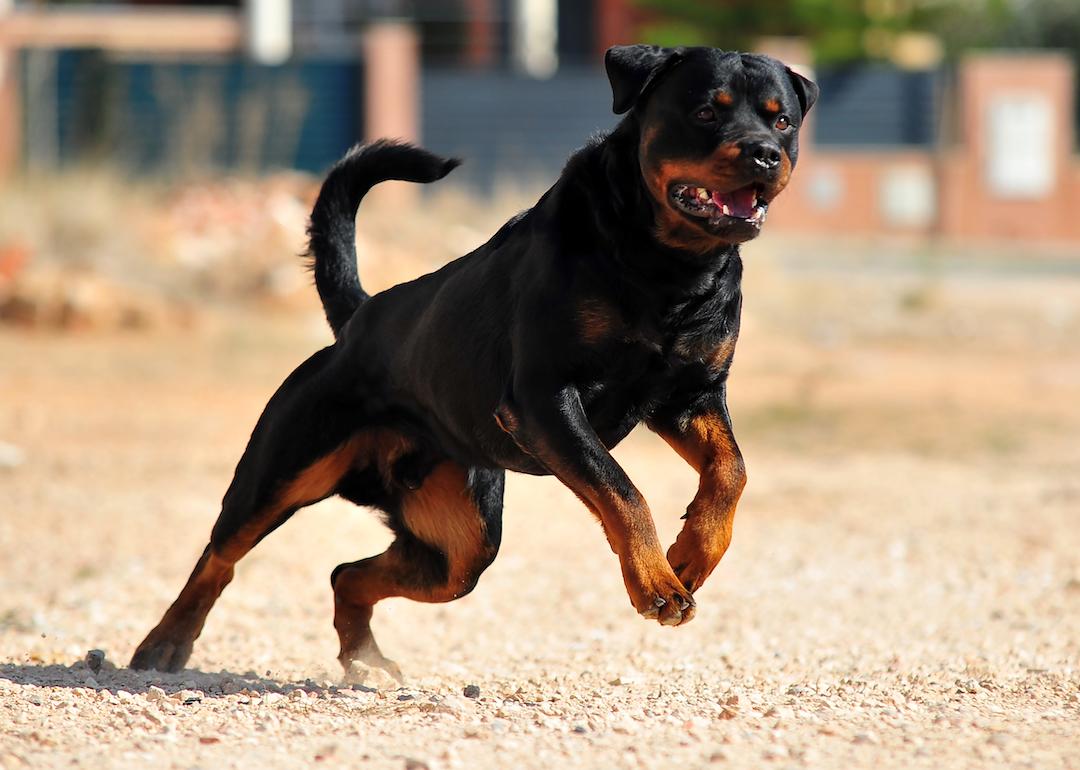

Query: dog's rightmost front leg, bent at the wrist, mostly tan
[[649, 388, 746, 592]]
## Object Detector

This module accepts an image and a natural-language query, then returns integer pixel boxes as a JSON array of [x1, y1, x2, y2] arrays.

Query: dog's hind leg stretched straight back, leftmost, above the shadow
[[131, 349, 363, 672]]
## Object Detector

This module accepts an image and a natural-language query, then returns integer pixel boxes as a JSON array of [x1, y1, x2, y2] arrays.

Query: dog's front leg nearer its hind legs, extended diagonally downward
[[496, 386, 694, 625]]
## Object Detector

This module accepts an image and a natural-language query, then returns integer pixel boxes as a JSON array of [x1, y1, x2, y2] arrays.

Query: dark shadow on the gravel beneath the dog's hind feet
[[0, 661, 374, 700]]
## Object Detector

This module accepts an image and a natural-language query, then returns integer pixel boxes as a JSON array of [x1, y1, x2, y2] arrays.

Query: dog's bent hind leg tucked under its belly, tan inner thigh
[[330, 461, 505, 680]]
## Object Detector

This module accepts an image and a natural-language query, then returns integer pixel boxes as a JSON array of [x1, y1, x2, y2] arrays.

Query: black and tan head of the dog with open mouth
[[605, 45, 818, 253]]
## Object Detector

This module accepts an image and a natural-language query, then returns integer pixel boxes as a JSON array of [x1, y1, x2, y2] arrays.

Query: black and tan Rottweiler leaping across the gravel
[[132, 45, 818, 672]]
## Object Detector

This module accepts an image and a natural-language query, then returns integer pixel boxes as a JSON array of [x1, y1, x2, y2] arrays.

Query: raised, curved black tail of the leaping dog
[[308, 139, 461, 337]]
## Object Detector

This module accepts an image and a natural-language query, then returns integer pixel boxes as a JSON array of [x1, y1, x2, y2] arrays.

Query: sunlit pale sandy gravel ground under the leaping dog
[[0, 241, 1080, 769]]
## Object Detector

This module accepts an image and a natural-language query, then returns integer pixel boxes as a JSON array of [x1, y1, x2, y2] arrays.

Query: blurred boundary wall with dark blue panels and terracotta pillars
[[0, 0, 1080, 241]]
